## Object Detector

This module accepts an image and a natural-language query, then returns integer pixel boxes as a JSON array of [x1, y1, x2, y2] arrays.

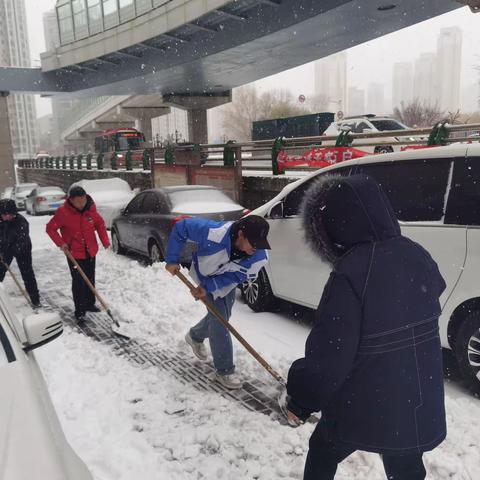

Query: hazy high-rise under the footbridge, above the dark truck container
[[315, 52, 347, 112]]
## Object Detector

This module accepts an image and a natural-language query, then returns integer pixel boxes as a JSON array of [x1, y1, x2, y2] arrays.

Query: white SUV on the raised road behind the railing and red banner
[[323, 115, 415, 153]]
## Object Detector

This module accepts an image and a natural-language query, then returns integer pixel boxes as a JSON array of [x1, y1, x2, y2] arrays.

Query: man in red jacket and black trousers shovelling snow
[[47, 187, 110, 322]]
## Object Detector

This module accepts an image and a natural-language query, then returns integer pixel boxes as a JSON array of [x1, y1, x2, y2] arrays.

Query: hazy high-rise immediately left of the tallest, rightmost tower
[[413, 53, 440, 107]]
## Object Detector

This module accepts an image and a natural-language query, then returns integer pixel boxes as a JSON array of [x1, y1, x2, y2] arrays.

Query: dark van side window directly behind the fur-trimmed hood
[[356, 159, 451, 222]]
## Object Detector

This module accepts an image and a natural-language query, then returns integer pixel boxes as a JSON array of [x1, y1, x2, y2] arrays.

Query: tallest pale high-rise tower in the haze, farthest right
[[437, 27, 462, 112]]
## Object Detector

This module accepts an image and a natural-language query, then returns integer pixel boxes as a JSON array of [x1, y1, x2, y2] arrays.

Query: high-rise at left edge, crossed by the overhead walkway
[[0, 0, 37, 159]]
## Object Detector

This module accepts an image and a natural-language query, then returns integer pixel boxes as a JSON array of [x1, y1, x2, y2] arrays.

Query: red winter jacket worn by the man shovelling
[[47, 195, 110, 260]]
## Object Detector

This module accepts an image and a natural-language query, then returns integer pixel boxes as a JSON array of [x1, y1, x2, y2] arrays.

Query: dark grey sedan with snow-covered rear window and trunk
[[111, 185, 248, 263]]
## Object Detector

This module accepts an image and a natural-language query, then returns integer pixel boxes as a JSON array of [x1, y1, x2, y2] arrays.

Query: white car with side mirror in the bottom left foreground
[[0, 286, 93, 480]]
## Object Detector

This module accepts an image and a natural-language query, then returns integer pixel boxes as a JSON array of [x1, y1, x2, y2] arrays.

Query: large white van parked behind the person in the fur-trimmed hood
[[241, 144, 480, 390]]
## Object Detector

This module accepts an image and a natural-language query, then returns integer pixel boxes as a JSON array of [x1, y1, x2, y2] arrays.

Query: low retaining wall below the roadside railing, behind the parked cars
[[18, 168, 296, 210]]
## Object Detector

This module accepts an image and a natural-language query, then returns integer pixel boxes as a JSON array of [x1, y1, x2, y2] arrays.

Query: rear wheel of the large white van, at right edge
[[454, 311, 480, 393]]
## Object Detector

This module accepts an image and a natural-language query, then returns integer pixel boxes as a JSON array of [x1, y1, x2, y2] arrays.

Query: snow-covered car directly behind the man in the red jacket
[[70, 178, 135, 229]]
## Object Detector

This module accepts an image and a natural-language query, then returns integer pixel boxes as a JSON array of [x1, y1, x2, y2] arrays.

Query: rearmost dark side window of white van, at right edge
[[445, 157, 480, 225]]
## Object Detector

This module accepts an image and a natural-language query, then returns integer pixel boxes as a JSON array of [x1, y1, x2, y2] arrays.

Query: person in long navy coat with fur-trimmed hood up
[[287, 175, 446, 480]]
